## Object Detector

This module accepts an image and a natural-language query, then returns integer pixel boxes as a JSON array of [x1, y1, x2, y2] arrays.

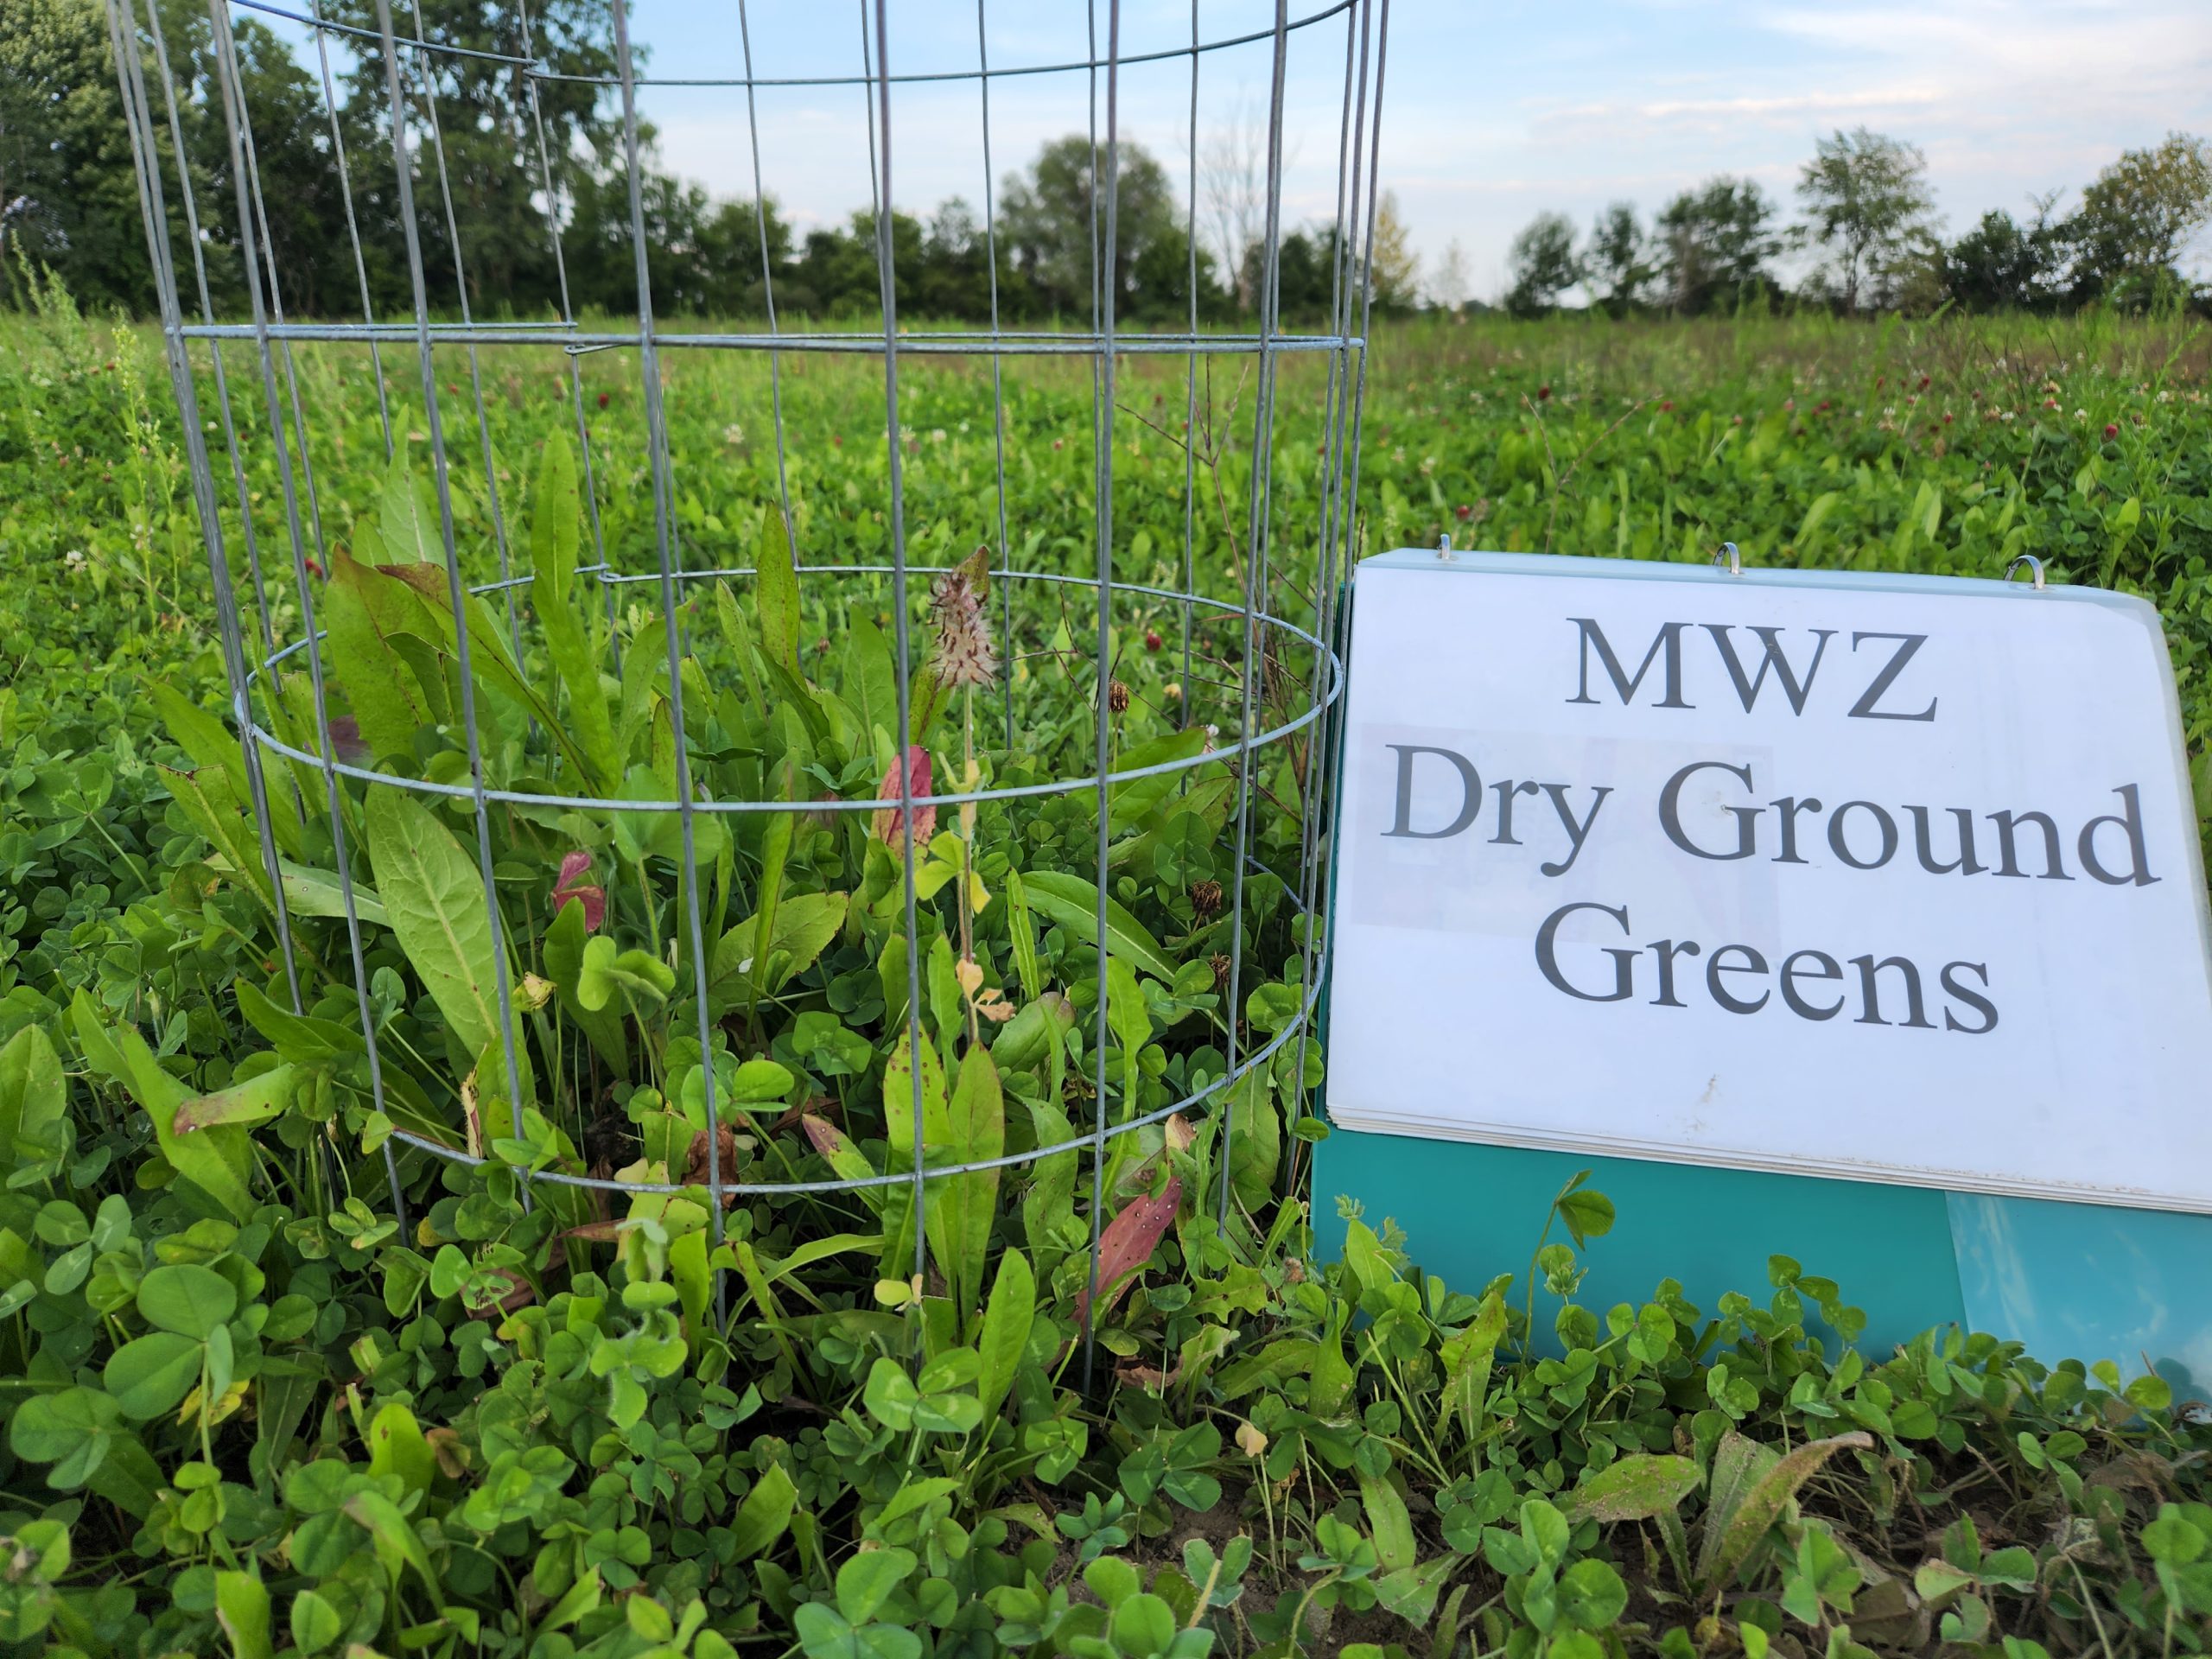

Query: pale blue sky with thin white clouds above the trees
[[263, 0, 2212, 296]]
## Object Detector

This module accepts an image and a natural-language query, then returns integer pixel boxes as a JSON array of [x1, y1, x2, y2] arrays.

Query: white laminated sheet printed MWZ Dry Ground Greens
[[1327, 550, 2212, 1212]]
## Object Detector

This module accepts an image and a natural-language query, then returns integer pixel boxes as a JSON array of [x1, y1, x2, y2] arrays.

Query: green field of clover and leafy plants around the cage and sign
[[0, 296, 2212, 1659]]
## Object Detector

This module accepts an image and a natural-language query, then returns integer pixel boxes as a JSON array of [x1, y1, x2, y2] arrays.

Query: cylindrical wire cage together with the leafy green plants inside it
[[108, 0, 1389, 1378]]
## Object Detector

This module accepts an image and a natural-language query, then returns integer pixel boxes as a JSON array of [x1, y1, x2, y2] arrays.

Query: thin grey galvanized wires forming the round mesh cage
[[108, 0, 1389, 1376]]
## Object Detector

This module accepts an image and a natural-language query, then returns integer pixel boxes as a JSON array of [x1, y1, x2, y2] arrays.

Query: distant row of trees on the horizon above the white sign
[[1486, 126, 2212, 316]]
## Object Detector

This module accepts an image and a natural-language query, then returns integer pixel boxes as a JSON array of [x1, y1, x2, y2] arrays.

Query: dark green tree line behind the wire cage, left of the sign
[[0, 0, 1418, 325]]
